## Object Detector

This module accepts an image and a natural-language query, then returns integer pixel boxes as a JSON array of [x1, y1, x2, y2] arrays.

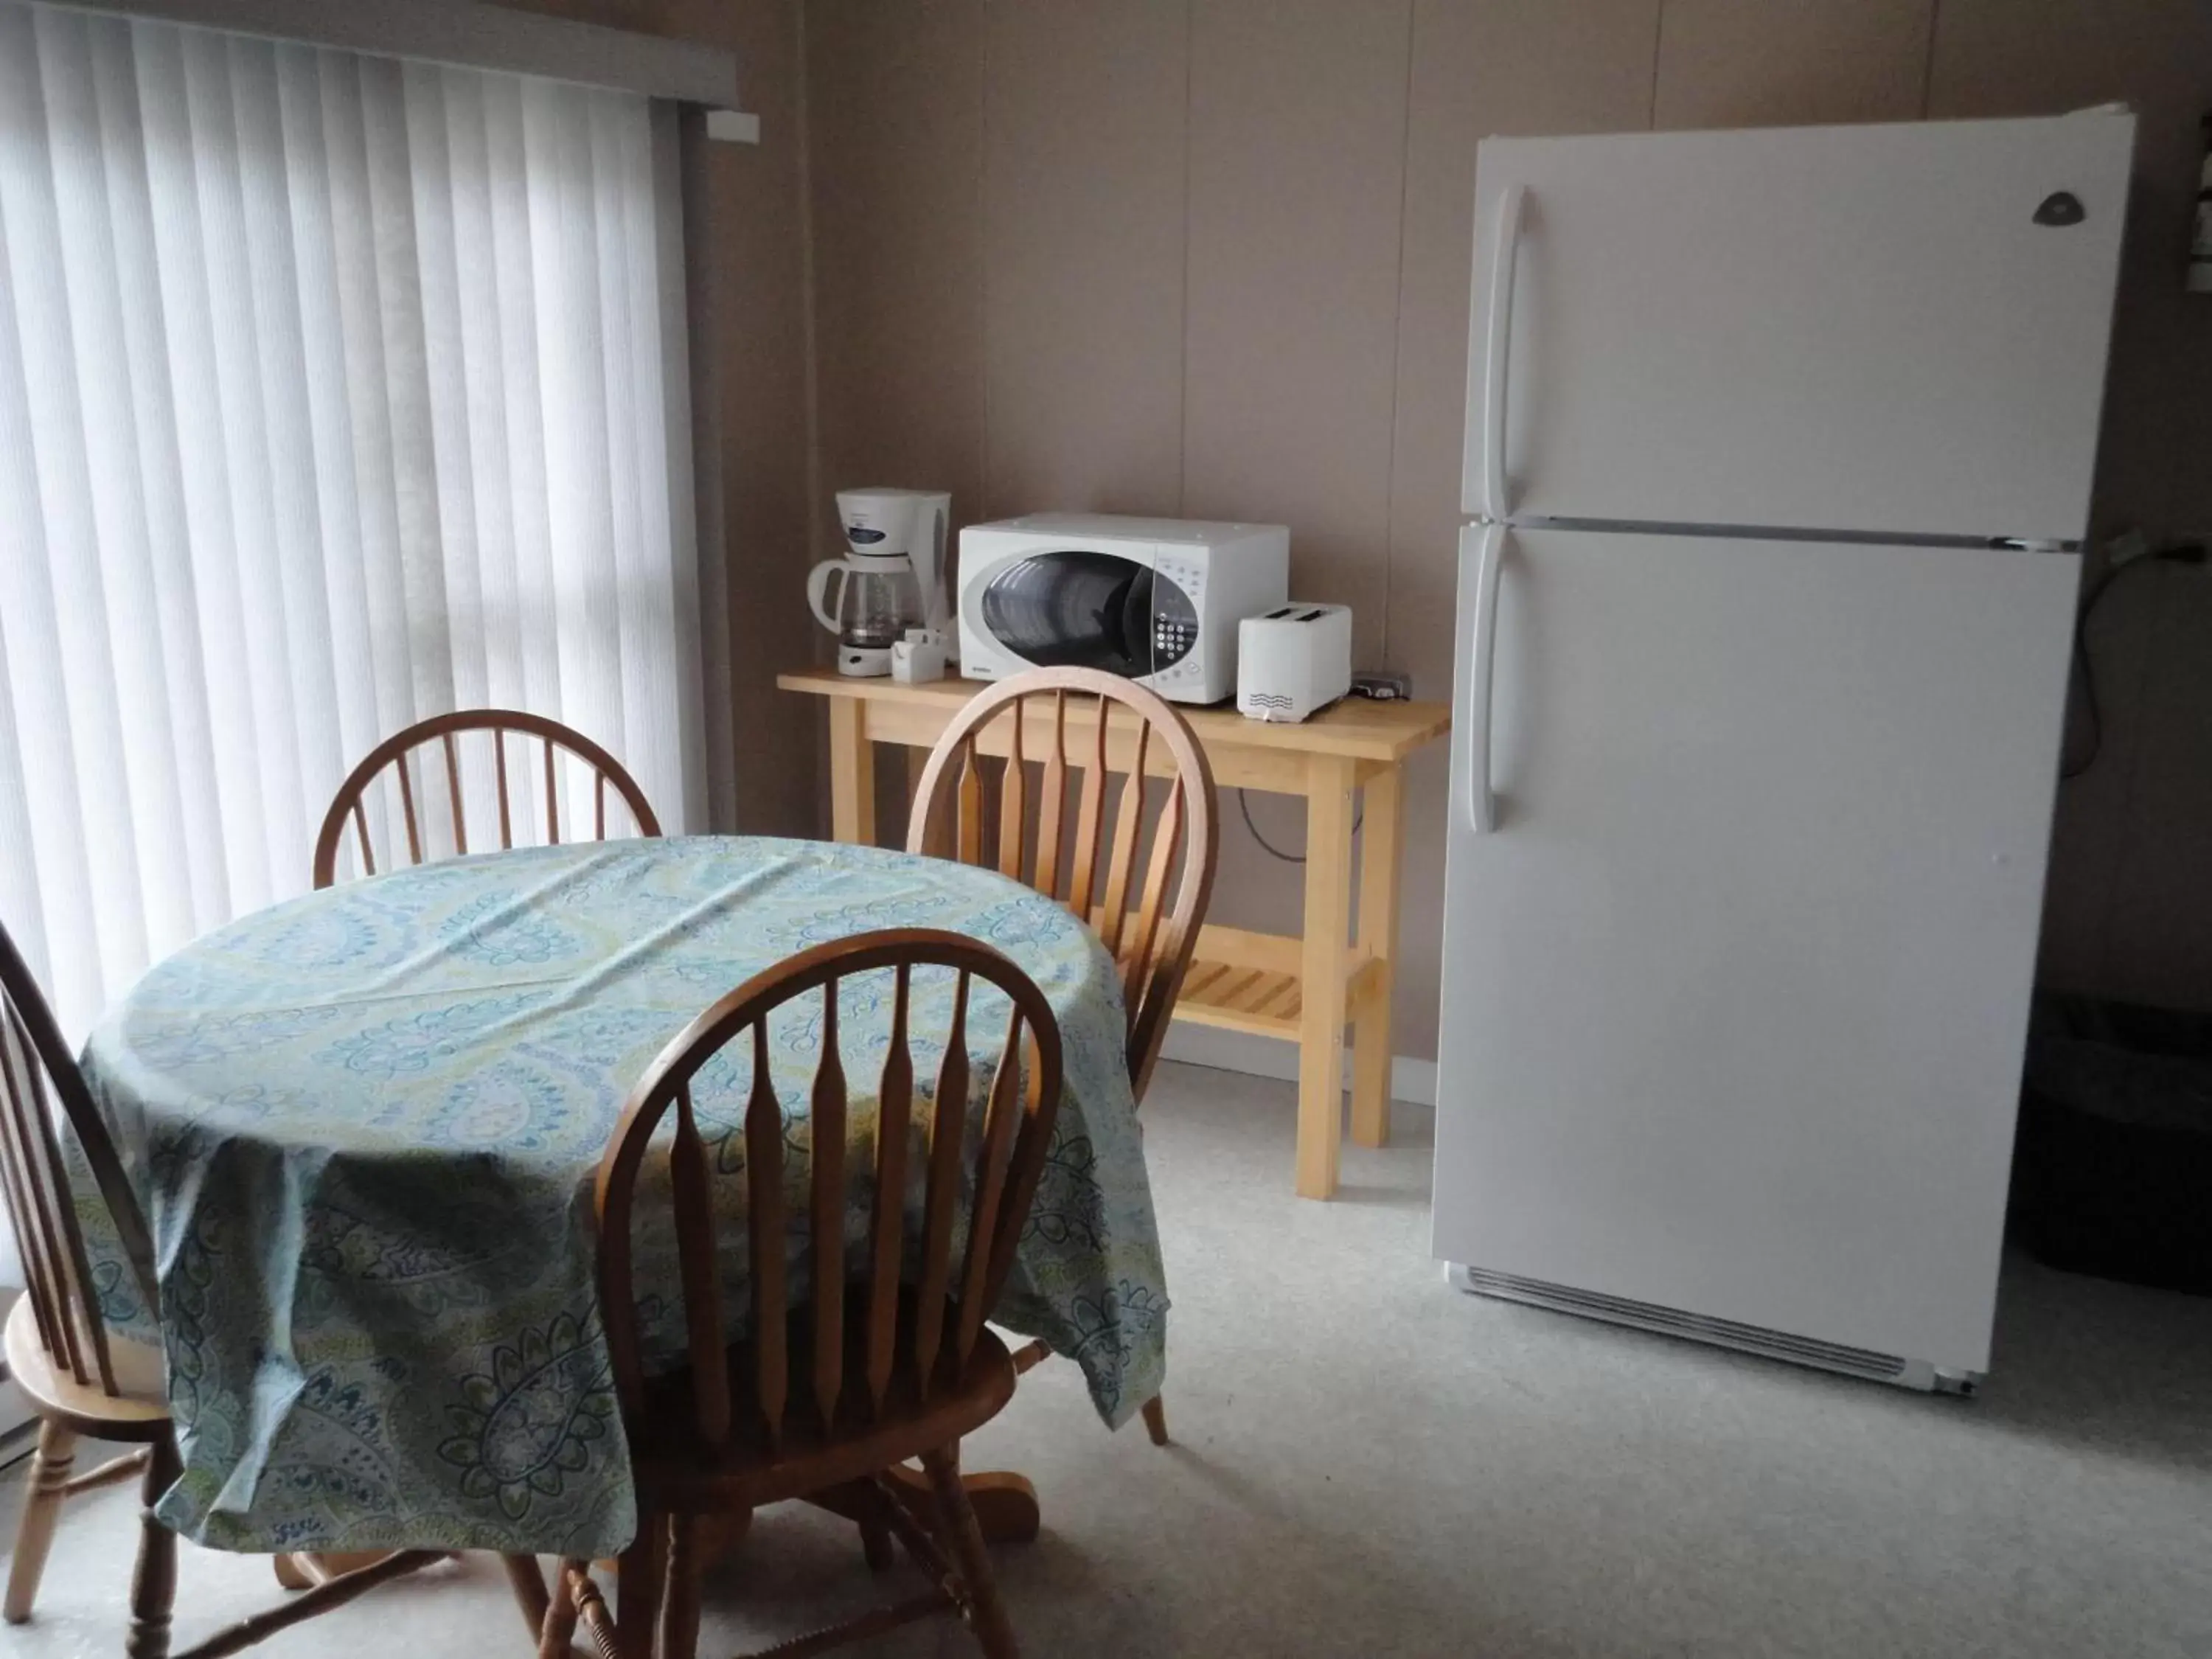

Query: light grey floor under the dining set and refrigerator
[[0, 1066, 2212, 1659]]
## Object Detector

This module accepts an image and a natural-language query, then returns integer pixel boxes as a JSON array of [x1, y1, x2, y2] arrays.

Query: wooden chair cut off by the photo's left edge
[[0, 927, 445, 1659]]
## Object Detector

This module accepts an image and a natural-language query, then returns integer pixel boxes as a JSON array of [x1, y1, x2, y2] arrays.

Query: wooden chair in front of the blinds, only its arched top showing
[[314, 708, 661, 887]]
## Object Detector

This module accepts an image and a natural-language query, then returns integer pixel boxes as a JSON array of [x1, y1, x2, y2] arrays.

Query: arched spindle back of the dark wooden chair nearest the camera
[[597, 929, 1060, 1455]]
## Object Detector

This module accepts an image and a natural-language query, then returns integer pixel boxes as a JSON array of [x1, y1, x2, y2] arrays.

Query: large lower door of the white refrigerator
[[1433, 526, 2079, 1371]]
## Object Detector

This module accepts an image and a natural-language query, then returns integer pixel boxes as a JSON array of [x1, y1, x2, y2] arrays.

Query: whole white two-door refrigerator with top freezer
[[1433, 111, 2135, 1391]]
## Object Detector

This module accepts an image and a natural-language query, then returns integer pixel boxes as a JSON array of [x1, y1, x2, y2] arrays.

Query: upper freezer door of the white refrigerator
[[1464, 115, 2135, 542]]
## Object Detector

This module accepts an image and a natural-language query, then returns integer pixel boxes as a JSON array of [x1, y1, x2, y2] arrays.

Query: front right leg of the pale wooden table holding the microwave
[[1298, 754, 1354, 1199]]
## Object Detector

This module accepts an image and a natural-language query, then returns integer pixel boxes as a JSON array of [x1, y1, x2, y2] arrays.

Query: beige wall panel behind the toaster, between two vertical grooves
[[1183, 0, 1411, 956]]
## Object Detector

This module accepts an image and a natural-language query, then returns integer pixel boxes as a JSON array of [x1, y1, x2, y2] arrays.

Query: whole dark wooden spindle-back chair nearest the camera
[[529, 929, 1060, 1659]]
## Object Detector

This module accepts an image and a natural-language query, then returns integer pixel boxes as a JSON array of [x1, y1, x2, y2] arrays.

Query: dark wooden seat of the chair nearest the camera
[[630, 1327, 1015, 1511]]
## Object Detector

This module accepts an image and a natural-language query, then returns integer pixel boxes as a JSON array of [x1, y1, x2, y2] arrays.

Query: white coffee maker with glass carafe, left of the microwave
[[807, 489, 958, 675]]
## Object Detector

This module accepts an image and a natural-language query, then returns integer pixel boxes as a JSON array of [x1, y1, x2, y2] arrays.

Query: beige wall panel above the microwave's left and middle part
[[982, 0, 1190, 518]]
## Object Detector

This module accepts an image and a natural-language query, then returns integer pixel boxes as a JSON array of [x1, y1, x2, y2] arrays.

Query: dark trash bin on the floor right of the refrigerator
[[2013, 995, 2212, 1296]]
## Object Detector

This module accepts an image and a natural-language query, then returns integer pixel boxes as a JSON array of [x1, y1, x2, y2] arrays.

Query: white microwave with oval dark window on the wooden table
[[960, 513, 1290, 703]]
